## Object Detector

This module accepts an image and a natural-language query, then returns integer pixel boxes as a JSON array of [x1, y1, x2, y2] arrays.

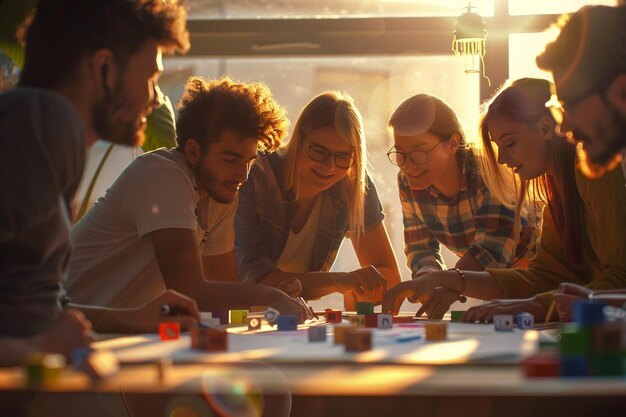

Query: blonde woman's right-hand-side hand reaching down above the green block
[[335, 265, 387, 303]]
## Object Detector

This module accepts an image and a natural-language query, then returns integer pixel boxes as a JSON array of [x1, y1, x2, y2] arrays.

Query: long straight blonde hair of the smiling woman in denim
[[282, 91, 367, 240]]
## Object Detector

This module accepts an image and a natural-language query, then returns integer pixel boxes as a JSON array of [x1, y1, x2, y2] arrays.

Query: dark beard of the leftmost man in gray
[[92, 83, 145, 146]]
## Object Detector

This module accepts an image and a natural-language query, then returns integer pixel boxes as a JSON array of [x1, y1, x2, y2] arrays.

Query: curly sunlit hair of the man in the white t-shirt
[[176, 77, 289, 152]]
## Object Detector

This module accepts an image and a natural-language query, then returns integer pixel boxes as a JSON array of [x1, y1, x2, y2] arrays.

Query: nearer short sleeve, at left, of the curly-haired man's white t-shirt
[[125, 167, 198, 237]]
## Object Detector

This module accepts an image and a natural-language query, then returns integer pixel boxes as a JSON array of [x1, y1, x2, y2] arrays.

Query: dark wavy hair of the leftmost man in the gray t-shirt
[[19, 0, 189, 88]]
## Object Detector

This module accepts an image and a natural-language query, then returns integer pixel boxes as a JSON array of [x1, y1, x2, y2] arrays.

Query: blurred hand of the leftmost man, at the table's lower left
[[31, 309, 94, 360]]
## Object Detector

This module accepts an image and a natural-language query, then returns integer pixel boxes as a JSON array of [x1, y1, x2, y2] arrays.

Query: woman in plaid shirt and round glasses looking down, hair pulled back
[[387, 94, 536, 278]]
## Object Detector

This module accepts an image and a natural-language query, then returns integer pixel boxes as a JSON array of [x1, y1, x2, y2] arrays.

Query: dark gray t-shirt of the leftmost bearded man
[[0, 87, 86, 337]]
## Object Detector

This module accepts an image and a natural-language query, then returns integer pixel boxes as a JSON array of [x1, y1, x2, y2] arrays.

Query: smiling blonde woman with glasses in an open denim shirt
[[235, 91, 400, 310]]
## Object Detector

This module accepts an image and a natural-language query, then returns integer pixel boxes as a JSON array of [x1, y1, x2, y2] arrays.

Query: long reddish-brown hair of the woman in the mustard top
[[480, 78, 582, 266]]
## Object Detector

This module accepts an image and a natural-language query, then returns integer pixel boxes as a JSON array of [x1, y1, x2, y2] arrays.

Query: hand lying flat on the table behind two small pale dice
[[463, 297, 548, 323]]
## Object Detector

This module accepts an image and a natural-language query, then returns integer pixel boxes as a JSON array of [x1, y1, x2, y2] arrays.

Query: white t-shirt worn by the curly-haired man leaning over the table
[[67, 148, 237, 307]]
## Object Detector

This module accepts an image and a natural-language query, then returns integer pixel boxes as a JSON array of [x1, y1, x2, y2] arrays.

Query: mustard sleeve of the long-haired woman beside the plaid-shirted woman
[[489, 206, 587, 298]]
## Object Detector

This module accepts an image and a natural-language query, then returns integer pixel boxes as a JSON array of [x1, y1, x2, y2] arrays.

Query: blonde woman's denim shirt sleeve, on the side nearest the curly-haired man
[[235, 167, 278, 283]]
